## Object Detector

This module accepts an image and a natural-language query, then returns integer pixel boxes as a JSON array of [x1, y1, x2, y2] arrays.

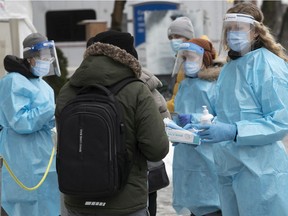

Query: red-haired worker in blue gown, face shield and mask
[[173, 38, 221, 216]]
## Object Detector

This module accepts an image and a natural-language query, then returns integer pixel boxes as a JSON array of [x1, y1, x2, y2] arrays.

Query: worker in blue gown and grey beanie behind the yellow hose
[[0, 33, 60, 216]]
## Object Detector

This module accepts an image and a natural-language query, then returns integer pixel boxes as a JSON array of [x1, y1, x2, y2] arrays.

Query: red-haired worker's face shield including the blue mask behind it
[[172, 42, 204, 77]]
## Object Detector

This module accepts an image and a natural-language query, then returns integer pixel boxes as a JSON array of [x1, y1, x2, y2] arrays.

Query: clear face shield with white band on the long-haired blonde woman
[[219, 13, 257, 56]]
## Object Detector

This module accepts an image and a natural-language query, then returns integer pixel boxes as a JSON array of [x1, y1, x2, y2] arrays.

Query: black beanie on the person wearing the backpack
[[86, 30, 138, 59]]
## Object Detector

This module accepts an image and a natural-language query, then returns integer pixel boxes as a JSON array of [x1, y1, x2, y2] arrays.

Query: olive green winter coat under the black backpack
[[56, 42, 169, 215]]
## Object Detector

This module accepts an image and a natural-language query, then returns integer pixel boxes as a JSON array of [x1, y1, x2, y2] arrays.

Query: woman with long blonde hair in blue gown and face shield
[[194, 2, 288, 216]]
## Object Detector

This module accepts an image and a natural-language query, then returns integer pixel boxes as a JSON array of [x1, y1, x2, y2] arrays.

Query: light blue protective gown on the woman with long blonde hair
[[213, 48, 288, 216]]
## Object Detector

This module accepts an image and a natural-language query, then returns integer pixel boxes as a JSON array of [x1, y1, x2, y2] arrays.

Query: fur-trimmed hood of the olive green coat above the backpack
[[70, 42, 141, 87]]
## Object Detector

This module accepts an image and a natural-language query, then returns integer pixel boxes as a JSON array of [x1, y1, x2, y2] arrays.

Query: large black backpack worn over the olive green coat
[[56, 77, 140, 198]]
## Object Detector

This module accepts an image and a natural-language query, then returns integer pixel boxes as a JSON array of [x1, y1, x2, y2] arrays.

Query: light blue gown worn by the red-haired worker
[[173, 78, 220, 215]]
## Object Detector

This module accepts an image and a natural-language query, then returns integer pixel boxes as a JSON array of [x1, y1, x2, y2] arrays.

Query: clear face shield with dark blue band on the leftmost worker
[[24, 40, 61, 76]]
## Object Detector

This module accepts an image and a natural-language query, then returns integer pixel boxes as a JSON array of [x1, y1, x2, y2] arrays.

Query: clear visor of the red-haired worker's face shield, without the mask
[[172, 42, 204, 77]]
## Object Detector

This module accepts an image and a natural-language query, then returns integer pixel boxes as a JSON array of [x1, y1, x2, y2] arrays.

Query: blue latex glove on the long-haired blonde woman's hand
[[192, 122, 237, 143]]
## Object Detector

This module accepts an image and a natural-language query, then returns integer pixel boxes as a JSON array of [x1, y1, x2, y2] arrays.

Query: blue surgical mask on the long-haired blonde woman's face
[[227, 31, 250, 52]]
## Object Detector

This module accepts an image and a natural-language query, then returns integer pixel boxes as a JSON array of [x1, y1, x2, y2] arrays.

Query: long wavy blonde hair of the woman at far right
[[224, 2, 288, 61]]
